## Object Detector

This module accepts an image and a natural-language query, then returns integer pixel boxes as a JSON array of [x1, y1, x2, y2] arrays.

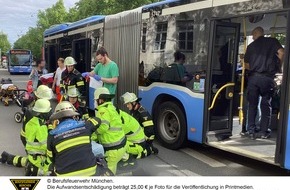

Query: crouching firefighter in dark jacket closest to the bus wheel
[[121, 92, 158, 154]]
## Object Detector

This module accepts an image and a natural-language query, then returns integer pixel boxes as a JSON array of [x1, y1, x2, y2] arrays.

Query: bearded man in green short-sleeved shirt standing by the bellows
[[82, 47, 119, 94]]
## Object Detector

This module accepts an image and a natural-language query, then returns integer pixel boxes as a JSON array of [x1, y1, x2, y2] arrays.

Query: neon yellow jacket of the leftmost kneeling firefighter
[[25, 116, 48, 168]]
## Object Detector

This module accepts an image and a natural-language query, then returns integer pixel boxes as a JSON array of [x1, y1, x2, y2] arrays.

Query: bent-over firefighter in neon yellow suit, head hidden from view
[[117, 109, 151, 159]]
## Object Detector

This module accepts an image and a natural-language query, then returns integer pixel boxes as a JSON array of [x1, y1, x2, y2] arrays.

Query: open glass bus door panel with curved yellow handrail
[[205, 21, 240, 140]]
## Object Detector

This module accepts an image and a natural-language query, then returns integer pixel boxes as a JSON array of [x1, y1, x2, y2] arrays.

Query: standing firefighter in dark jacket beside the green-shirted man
[[60, 57, 85, 95]]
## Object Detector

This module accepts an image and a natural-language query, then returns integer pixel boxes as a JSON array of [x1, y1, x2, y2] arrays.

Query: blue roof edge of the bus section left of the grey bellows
[[44, 15, 105, 36]]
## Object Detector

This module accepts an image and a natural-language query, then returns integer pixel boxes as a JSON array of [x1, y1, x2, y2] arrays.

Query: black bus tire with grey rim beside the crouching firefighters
[[155, 102, 187, 150]]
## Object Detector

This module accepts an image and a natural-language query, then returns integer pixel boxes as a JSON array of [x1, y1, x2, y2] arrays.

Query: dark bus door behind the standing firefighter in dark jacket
[[72, 38, 92, 73]]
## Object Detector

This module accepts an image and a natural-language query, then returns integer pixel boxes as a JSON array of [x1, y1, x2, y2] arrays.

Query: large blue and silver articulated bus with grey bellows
[[44, 0, 290, 170]]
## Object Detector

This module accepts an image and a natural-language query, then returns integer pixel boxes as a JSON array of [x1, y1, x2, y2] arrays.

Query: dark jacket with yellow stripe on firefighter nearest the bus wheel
[[131, 105, 155, 140]]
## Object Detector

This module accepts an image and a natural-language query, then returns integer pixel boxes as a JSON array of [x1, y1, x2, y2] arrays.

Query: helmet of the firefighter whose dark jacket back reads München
[[50, 101, 80, 120]]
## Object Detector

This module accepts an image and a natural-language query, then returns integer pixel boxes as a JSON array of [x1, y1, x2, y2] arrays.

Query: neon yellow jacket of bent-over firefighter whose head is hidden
[[117, 110, 146, 144]]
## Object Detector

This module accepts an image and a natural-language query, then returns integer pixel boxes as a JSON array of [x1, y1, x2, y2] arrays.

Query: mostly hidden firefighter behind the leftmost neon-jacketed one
[[20, 85, 53, 147]]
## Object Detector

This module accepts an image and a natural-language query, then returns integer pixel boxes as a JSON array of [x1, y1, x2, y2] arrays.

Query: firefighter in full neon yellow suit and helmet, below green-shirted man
[[88, 87, 126, 174]]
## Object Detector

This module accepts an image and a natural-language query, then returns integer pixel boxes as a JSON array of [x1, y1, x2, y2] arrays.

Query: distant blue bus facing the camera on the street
[[7, 49, 33, 74]]
